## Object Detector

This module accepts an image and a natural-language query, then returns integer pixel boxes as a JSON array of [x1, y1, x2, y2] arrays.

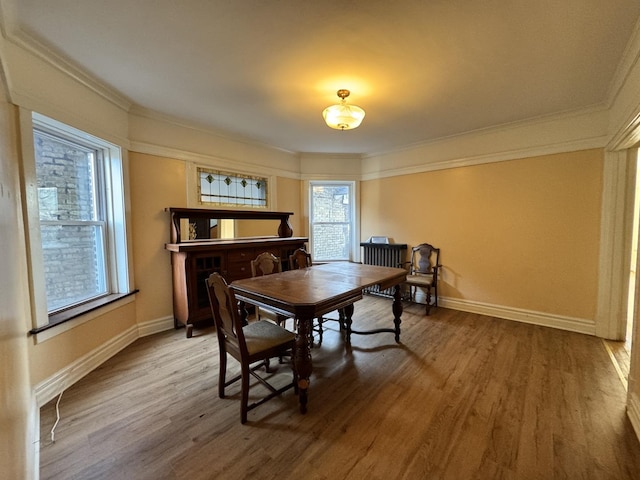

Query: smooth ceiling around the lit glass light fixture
[[3, 0, 640, 154]]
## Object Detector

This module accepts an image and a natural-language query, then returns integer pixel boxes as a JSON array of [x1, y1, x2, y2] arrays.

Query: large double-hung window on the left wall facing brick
[[27, 113, 129, 327]]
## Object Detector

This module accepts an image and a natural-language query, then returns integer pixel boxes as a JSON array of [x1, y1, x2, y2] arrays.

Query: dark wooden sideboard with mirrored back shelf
[[165, 208, 308, 337]]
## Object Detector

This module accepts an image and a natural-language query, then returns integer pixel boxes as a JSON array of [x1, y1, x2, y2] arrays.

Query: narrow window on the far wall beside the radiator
[[309, 182, 356, 261]]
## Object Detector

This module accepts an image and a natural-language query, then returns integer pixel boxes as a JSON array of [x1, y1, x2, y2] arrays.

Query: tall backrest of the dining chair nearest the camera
[[205, 273, 247, 354]]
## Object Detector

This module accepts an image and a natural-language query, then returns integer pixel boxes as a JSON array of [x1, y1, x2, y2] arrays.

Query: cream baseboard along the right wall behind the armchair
[[438, 297, 596, 335]]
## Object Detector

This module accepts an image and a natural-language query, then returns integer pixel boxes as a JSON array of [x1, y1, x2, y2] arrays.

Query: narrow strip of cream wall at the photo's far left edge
[[0, 67, 37, 479]]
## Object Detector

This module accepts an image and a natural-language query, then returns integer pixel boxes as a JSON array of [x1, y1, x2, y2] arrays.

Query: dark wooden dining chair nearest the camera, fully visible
[[205, 273, 298, 423]]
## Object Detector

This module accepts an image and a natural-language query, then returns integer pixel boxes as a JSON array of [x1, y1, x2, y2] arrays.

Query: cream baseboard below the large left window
[[34, 325, 138, 408]]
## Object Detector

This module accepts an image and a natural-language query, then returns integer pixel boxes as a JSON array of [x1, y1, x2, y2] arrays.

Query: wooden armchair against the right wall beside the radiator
[[404, 243, 442, 315]]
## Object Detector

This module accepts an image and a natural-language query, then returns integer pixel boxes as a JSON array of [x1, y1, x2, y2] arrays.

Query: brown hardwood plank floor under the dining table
[[40, 296, 640, 480]]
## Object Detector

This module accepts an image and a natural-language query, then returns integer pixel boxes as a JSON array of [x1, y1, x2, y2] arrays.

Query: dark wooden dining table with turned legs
[[231, 262, 407, 413]]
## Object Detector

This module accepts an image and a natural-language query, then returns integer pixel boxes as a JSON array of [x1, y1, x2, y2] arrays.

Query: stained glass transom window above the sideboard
[[198, 168, 267, 208]]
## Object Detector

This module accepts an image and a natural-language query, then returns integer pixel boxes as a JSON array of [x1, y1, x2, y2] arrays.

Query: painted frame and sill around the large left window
[[20, 109, 132, 339]]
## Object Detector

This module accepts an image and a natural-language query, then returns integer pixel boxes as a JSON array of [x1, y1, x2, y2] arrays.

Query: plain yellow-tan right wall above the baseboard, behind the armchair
[[361, 149, 603, 320]]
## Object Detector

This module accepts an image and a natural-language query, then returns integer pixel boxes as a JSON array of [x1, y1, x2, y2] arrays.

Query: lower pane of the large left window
[[40, 225, 107, 312]]
